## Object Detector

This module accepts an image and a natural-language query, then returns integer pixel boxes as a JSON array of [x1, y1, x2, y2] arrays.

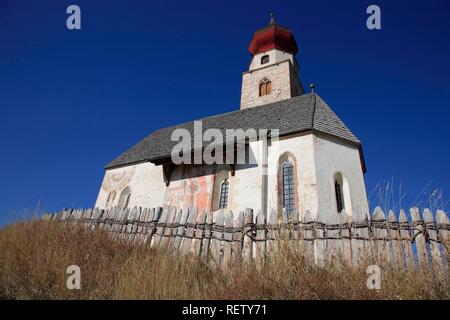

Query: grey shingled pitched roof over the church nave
[[106, 93, 361, 169]]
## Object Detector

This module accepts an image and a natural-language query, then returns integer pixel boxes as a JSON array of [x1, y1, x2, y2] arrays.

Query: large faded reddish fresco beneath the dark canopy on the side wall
[[164, 166, 213, 212]]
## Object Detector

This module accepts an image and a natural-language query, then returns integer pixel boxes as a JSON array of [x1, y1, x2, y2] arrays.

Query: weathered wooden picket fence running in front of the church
[[44, 208, 450, 271]]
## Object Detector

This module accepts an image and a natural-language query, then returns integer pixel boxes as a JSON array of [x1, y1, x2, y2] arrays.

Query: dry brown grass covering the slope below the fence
[[0, 221, 450, 299]]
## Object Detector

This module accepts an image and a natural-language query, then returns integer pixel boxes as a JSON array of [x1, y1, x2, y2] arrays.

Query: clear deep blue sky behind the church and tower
[[0, 0, 450, 224]]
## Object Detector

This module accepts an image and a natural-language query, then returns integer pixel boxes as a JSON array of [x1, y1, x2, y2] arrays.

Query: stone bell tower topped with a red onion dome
[[241, 14, 304, 109]]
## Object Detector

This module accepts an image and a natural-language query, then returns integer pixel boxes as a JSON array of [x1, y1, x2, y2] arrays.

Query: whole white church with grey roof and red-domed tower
[[95, 15, 368, 221]]
